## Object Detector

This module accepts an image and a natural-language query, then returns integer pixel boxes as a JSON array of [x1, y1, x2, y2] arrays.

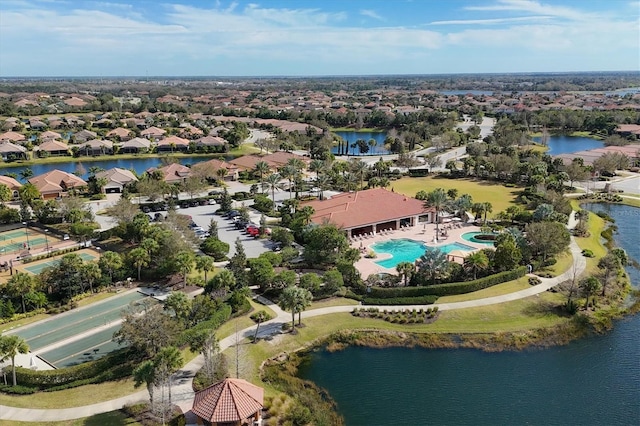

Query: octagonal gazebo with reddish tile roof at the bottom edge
[[191, 379, 264, 426]]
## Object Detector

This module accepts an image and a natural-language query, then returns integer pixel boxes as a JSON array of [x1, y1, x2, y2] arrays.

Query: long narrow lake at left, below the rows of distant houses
[[0, 157, 211, 179]]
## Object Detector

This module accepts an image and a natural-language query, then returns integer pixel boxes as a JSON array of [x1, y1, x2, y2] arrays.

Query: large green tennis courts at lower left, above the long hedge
[[16, 291, 146, 359]]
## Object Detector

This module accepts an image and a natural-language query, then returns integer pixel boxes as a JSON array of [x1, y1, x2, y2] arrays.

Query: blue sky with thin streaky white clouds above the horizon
[[0, 0, 640, 77]]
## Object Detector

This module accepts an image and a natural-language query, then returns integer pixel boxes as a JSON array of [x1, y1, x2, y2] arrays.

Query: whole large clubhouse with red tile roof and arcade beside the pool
[[302, 188, 435, 237]]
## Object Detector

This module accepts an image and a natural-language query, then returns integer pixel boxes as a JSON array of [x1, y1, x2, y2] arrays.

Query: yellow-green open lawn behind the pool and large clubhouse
[[391, 177, 520, 217]]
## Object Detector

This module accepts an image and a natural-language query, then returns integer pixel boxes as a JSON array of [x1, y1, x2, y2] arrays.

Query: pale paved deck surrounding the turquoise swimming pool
[[351, 223, 490, 278]]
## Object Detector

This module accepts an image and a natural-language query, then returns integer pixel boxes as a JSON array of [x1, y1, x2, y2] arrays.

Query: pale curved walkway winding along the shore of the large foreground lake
[[0, 235, 586, 422]]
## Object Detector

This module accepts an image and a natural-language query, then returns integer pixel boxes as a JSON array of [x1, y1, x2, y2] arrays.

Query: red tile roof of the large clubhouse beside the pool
[[304, 188, 435, 229]]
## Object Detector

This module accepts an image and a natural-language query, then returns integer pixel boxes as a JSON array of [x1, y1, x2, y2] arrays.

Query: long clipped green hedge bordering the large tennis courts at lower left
[[16, 349, 139, 389]]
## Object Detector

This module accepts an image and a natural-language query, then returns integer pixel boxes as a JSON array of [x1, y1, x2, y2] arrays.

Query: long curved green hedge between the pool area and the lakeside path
[[368, 266, 527, 304]]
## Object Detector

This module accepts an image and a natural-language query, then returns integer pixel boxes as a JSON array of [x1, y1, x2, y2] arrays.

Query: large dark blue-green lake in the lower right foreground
[[299, 204, 640, 425]]
